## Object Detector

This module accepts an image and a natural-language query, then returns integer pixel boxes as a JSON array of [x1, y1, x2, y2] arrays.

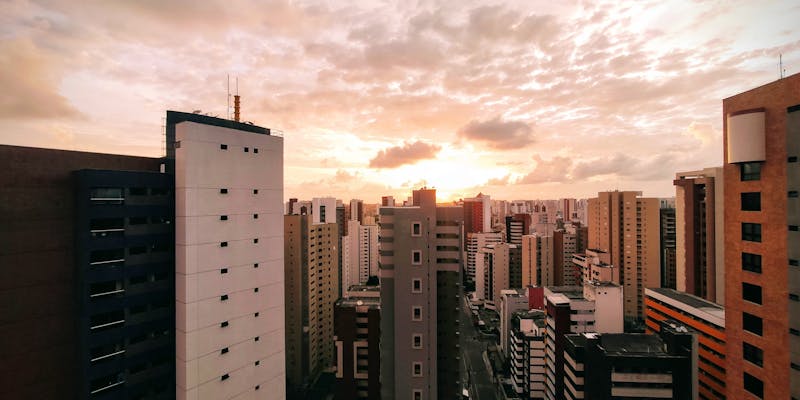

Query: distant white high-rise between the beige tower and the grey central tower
[[342, 219, 379, 288]]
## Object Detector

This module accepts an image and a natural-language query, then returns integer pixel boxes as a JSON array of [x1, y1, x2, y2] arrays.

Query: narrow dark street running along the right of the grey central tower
[[460, 299, 498, 400]]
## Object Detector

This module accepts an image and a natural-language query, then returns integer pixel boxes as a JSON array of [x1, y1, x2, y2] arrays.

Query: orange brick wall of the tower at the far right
[[722, 75, 800, 399]]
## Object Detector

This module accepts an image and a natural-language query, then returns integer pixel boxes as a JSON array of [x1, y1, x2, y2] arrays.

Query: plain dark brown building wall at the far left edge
[[0, 145, 161, 399]]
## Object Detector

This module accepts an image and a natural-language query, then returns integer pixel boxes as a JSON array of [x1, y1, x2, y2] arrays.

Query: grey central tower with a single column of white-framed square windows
[[380, 189, 464, 399]]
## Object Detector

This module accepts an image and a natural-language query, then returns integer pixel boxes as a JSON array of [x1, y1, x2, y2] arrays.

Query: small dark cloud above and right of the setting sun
[[458, 117, 534, 150]]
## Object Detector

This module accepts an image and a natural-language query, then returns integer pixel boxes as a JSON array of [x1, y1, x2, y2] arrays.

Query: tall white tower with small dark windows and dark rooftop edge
[[173, 112, 285, 399]]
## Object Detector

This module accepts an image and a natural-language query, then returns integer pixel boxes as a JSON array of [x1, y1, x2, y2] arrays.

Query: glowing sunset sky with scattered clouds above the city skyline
[[0, 0, 800, 203]]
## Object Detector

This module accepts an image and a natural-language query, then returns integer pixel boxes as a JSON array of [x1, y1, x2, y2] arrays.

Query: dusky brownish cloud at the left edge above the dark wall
[[0, 39, 81, 119]]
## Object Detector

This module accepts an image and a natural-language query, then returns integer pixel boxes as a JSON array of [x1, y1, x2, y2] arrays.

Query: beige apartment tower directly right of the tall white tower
[[283, 215, 339, 398]]
